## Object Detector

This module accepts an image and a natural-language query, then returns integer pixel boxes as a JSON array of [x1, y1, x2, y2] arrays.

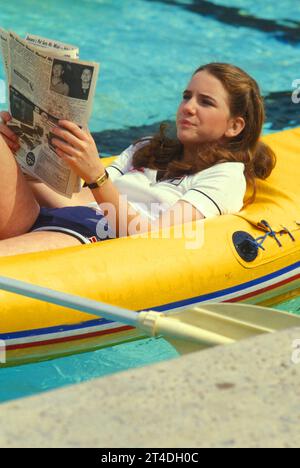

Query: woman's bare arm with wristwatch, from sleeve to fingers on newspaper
[[52, 121, 204, 237]]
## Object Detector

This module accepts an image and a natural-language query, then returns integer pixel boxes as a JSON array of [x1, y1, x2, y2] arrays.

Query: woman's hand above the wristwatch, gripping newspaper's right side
[[52, 120, 105, 184]]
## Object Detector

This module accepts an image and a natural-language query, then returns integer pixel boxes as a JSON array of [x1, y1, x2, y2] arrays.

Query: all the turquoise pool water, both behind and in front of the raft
[[0, 0, 300, 402]]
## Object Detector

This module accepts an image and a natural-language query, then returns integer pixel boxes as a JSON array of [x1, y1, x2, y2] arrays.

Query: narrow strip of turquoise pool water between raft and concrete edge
[[0, 299, 300, 403]]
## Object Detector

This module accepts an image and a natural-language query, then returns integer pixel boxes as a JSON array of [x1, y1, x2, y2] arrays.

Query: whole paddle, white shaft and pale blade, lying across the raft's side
[[0, 276, 300, 353]]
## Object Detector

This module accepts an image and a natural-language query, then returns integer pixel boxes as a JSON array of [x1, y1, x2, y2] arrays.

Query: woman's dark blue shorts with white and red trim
[[30, 206, 116, 244]]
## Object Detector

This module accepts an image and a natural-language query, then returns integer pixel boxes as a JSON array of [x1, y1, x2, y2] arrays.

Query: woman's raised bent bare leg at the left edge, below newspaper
[[0, 137, 39, 239]]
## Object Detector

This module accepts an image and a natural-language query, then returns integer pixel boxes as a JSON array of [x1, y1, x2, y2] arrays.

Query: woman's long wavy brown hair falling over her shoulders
[[133, 63, 276, 204]]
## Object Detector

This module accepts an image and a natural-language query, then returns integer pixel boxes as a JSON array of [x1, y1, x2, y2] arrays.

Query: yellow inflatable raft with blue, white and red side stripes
[[0, 129, 300, 365]]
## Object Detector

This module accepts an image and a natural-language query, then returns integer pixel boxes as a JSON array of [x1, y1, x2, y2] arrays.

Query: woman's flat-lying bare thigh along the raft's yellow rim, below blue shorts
[[0, 231, 82, 257]]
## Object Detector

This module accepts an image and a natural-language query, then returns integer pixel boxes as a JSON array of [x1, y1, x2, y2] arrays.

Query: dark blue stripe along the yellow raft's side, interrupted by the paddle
[[0, 262, 300, 341]]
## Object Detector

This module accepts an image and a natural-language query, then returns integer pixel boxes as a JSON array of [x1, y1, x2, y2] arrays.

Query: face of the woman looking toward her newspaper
[[176, 71, 230, 146]]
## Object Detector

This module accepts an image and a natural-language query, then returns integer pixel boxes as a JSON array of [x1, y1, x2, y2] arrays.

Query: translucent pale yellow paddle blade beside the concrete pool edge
[[139, 303, 300, 354]]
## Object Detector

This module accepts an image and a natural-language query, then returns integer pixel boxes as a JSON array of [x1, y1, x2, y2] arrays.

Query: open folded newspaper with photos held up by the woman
[[0, 29, 99, 198]]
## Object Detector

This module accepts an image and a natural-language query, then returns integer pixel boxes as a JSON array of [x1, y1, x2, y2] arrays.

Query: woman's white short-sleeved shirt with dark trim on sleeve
[[107, 142, 246, 220]]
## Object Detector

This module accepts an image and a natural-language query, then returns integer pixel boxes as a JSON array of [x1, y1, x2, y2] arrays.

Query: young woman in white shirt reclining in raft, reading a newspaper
[[0, 63, 275, 256]]
